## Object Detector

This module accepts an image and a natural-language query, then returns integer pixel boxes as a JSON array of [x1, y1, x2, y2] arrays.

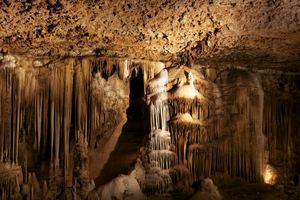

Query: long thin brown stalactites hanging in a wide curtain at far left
[[0, 57, 130, 197]]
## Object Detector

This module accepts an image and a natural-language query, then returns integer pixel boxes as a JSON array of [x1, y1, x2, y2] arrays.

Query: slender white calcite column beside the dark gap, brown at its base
[[143, 69, 176, 195]]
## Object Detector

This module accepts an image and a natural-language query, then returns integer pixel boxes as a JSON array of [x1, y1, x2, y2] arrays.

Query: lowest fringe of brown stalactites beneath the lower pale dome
[[170, 117, 215, 181]]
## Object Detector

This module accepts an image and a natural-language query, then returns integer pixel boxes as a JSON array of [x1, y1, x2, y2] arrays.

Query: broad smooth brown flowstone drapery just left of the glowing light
[[218, 70, 266, 182]]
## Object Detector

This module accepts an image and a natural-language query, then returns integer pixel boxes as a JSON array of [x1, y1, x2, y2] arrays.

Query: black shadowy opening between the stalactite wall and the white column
[[95, 68, 150, 186]]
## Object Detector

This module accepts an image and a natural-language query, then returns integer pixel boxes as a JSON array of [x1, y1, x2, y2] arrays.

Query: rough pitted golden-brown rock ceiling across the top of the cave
[[0, 0, 300, 67]]
